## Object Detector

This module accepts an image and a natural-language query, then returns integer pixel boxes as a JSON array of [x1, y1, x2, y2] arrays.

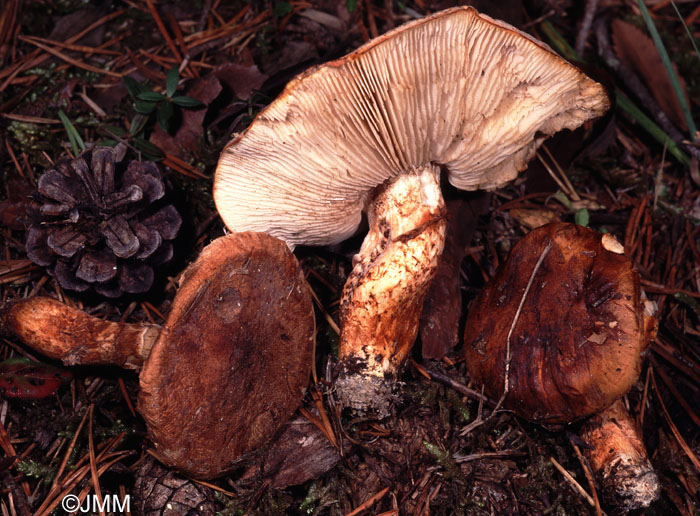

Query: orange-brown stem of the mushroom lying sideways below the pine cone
[[0, 297, 160, 369]]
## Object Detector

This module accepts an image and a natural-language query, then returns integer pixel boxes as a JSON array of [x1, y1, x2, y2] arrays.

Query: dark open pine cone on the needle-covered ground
[[26, 147, 182, 297]]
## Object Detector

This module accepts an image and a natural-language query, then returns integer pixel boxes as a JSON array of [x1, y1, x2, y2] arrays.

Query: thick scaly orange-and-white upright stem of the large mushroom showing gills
[[336, 165, 447, 417]]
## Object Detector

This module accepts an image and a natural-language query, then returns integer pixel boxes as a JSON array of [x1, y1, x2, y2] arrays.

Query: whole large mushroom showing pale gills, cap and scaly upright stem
[[214, 7, 608, 416]]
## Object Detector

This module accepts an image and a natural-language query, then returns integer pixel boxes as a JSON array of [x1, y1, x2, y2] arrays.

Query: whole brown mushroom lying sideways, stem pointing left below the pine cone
[[0, 233, 315, 479]]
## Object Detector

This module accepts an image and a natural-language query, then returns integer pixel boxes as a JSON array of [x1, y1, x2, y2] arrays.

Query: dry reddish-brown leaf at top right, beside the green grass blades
[[611, 19, 688, 130]]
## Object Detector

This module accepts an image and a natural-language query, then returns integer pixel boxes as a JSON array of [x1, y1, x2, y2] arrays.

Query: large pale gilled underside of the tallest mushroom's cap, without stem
[[214, 7, 608, 245]]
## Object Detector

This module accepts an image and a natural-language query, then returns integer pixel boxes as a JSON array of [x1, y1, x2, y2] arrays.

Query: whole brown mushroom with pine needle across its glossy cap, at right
[[464, 223, 659, 510]]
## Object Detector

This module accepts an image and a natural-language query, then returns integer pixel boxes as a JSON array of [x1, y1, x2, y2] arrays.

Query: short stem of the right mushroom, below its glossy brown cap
[[581, 400, 660, 511]]
